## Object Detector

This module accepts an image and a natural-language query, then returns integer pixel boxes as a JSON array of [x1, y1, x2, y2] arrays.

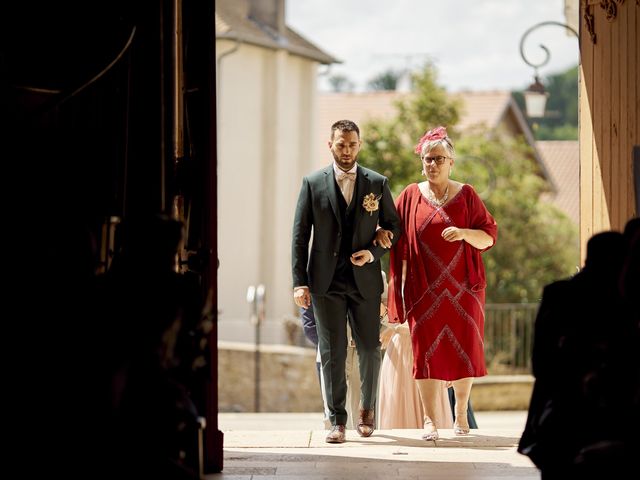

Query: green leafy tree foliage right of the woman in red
[[454, 131, 579, 303]]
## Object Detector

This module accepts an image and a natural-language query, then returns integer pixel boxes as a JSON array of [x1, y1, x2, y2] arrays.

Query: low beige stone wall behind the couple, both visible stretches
[[218, 341, 533, 412]]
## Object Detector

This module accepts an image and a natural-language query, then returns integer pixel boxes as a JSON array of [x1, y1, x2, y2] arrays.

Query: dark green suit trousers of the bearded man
[[312, 267, 381, 425]]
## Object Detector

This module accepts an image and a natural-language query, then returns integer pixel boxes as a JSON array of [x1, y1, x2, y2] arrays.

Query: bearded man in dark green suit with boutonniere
[[292, 120, 400, 443]]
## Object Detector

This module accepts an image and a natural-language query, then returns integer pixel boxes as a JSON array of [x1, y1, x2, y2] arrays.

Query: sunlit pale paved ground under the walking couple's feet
[[206, 412, 540, 480]]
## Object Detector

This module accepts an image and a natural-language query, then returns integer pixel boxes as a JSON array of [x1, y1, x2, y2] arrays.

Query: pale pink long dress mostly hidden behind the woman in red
[[378, 326, 453, 430]]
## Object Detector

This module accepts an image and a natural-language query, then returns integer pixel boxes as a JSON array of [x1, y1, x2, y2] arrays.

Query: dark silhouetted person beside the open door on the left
[[97, 215, 204, 478]]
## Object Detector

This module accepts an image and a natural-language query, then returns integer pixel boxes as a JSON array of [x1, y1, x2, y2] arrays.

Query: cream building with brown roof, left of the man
[[215, 0, 336, 343]]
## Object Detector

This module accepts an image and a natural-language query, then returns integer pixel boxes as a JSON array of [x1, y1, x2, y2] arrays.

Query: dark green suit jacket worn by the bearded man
[[292, 164, 400, 298]]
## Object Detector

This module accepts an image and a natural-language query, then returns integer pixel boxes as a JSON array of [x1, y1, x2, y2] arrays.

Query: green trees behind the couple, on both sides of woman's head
[[359, 65, 579, 303]]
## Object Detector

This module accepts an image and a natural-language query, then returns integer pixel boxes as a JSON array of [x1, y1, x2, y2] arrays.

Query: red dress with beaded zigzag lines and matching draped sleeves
[[389, 184, 497, 380]]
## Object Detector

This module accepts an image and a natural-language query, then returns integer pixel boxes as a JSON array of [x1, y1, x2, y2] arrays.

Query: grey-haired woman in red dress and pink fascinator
[[388, 127, 497, 440]]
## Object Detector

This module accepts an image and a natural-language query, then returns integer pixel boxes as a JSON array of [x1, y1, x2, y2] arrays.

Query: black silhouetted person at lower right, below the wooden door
[[518, 232, 637, 480]]
